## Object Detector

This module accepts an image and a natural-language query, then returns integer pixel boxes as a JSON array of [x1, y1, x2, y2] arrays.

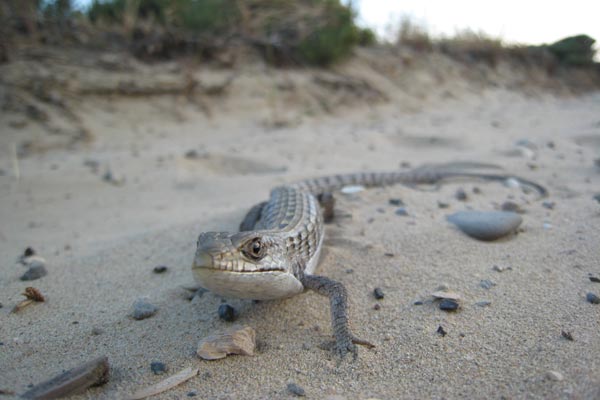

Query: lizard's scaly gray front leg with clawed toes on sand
[[300, 275, 375, 359]]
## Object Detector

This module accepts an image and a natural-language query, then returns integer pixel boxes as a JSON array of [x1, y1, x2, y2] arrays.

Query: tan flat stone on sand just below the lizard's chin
[[196, 326, 256, 360]]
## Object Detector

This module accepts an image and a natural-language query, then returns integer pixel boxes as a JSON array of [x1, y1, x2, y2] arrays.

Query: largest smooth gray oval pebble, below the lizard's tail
[[448, 211, 523, 240]]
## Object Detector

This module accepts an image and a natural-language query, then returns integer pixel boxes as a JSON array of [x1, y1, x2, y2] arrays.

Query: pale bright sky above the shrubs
[[352, 0, 600, 44]]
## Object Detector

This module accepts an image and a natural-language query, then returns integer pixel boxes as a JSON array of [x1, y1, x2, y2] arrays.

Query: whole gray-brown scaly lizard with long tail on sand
[[192, 162, 547, 358]]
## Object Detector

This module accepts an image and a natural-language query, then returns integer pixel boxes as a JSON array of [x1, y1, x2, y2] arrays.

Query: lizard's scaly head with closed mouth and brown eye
[[192, 232, 303, 300]]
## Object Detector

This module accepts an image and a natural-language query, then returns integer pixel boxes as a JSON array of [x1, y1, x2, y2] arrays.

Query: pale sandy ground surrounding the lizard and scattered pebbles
[[0, 49, 600, 399]]
